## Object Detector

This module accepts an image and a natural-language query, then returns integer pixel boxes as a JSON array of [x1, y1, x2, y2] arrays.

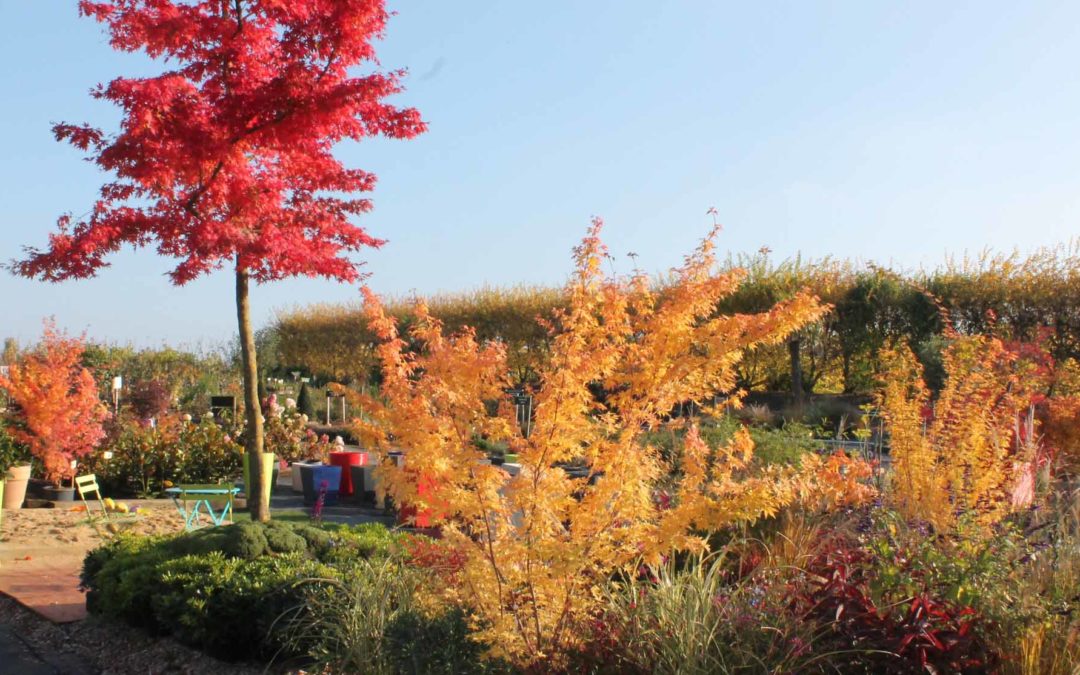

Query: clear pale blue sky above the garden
[[0, 0, 1080, 346]]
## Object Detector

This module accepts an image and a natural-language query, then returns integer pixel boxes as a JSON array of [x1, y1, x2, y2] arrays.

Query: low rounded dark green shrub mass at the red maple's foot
[[82, 522, 397, 660]]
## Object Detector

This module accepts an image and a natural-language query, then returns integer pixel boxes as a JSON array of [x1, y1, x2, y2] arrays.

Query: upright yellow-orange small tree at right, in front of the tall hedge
[[878, 334, 1050, 530]]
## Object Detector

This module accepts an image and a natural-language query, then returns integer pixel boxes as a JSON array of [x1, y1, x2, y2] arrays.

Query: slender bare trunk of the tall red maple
[[237, 268, 270, 523]]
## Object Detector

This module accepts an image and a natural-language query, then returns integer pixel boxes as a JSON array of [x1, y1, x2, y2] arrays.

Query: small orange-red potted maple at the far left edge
[[0, 322, 109, 483]]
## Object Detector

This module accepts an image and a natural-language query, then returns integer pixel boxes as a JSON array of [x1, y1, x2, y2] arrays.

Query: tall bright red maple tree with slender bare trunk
[[14, 0, 426, 519]]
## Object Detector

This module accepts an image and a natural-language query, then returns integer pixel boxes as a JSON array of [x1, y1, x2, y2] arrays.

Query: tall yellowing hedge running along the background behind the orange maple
[[273, 242, 1080, 393]]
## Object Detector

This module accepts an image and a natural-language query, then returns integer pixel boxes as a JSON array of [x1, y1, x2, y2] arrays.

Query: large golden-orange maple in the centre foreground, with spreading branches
[[345, 220, 865, 666]]
